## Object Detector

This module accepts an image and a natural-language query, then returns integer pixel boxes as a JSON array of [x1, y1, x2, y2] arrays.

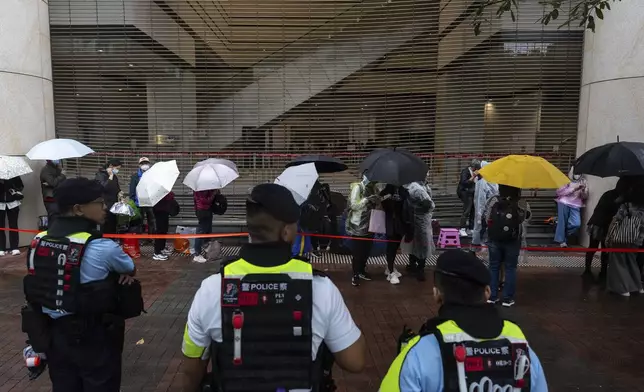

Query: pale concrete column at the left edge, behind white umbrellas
[[0, 0, 55, 245]]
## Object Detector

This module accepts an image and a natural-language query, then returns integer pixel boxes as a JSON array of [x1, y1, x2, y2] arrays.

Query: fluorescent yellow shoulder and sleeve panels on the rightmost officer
[[380, 320, 527, 392]]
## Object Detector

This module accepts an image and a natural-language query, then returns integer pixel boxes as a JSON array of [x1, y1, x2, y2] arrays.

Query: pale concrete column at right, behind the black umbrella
[[577, 1, 644, 243]]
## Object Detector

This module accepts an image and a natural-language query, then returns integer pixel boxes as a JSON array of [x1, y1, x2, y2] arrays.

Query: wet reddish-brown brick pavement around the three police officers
[[0, 250, 644, 392]]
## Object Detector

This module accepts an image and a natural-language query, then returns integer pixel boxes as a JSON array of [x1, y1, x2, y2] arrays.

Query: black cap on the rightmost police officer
[[436, 249, 490, 286]]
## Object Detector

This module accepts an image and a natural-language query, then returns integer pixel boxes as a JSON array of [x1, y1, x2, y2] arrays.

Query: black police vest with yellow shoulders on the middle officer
[[213, 259, 314, 392]]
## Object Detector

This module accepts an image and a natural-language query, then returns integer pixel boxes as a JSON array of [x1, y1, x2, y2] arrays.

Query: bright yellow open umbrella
[[479, 155, 570, 189]]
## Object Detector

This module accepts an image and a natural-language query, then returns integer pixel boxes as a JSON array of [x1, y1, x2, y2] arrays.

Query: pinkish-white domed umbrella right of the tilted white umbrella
[[183, 159, 239, 191]]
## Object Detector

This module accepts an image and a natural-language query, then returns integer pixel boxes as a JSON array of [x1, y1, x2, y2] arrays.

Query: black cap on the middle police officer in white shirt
[[246, 183, 300, 223]]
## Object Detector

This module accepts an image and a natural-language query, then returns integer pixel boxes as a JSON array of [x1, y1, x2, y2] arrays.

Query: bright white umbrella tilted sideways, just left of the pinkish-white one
[[136, 161, 179, 207]]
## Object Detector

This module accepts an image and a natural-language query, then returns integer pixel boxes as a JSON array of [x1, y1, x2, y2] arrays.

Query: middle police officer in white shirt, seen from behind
[[183, 184, 365, 392]]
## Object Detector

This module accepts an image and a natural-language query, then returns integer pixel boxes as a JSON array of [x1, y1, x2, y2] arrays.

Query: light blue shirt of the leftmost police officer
[[42, 238, 134, 319]]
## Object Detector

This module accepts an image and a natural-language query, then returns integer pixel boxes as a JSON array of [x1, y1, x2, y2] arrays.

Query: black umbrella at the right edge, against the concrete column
[[574, 142, 644, 177]]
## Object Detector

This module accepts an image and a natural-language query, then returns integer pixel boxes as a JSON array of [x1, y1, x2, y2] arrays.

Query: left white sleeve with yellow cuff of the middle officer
[[182, 274, 222, 359]]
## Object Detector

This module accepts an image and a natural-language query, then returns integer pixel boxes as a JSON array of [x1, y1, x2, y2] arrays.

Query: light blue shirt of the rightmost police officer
[[398, 335, 548, 392]]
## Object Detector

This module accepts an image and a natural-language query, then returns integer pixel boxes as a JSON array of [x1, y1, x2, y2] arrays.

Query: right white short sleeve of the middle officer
[[313, 277, 361, 353]]
